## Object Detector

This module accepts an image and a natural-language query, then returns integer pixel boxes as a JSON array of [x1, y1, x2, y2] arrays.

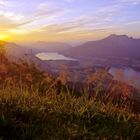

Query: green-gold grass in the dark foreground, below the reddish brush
[[0, 86, 140, 140]]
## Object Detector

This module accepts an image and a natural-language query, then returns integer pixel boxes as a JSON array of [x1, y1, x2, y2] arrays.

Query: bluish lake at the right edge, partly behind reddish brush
[[109, 67, 140, 89]]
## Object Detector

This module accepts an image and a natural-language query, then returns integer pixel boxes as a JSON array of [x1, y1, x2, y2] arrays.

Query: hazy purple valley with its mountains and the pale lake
[[1, 34, 140, 87]]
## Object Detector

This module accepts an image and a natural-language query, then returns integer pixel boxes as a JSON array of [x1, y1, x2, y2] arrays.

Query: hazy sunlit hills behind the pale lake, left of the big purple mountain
[[0, 41, 71, 58]]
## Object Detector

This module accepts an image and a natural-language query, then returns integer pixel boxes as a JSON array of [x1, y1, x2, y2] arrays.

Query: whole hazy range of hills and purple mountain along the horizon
[[1, 34, 140, 60]]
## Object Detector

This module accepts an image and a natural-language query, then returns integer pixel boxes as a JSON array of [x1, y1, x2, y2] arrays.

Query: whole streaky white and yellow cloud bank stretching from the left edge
[[0, 0, 119, 34]]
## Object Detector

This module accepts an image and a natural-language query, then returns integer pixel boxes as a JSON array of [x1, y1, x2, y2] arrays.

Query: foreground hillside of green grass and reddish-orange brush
[[0, 45, 140, 140]]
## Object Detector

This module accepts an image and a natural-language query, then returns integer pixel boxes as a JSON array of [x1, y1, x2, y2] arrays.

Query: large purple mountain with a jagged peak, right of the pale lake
[[67, 34, 140, 60]]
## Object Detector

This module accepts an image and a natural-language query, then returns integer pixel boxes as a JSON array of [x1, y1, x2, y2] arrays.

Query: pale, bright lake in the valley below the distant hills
[[36, 52, 76, 61]]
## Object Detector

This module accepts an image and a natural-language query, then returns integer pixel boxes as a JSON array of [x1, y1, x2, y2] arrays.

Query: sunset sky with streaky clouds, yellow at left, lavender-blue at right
[[0, 0, 140, 42]]
